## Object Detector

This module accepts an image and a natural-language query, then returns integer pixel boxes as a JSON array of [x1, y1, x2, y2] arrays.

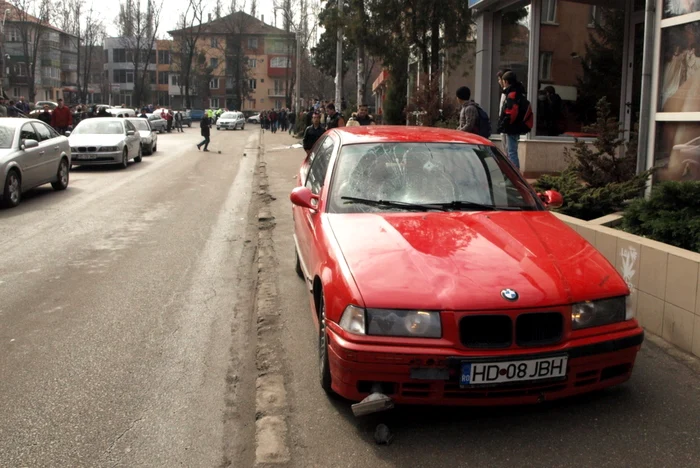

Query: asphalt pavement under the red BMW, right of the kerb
[[264, 133, 700, 468]]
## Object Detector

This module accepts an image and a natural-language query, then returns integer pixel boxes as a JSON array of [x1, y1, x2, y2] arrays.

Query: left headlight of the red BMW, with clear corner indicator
[[340, 306, 442, 338]]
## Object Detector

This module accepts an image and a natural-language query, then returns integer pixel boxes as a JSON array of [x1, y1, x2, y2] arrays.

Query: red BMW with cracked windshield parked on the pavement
[[290, 126, 644, 414]]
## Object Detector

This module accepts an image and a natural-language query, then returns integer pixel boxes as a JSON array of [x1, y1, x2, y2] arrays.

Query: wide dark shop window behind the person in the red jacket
[[529, 0, 626, 137]]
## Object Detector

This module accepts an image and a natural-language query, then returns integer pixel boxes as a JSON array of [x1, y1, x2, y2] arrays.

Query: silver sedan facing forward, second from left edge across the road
[[68, 117, 142, 168]]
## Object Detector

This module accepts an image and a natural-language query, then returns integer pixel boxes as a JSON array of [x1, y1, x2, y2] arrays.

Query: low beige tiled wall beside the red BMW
[[556, 214, 700, 357]]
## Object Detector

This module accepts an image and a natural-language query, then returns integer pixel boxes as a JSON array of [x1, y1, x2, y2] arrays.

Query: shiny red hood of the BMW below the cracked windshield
[[327, 211, 628, 310]]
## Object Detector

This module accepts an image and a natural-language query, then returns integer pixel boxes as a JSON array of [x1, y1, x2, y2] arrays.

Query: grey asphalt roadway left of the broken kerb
[[0, 126, 259, 467]]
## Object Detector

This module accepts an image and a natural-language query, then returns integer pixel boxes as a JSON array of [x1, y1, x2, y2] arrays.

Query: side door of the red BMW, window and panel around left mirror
[[294, 136, 334, 274]]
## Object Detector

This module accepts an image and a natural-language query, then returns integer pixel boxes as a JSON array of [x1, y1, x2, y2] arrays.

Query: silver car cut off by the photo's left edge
[[0, 118, 71, 207]]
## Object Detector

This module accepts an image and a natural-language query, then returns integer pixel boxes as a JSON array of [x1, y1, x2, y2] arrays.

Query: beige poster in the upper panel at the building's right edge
[[659, 21, 700, 112]]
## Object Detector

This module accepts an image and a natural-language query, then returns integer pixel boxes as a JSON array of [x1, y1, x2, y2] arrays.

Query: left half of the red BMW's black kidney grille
[[459, 315, 513, 348]]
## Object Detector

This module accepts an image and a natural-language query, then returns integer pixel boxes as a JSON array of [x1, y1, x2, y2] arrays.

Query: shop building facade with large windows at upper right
[[468, 0, 700, 180]]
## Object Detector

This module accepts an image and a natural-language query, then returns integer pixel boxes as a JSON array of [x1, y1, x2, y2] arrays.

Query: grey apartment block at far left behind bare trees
[[0, 2, 78, 101]]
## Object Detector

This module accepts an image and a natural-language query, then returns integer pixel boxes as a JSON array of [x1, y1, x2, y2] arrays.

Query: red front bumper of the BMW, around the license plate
[[327, 327, 644, 406]]
